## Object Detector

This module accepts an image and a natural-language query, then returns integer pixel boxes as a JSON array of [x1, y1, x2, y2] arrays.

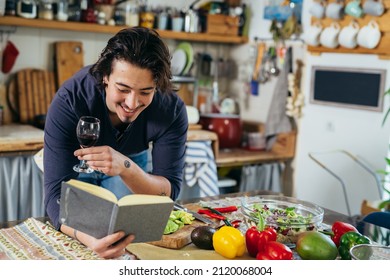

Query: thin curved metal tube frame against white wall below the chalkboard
[[309, 150, 383, 216]]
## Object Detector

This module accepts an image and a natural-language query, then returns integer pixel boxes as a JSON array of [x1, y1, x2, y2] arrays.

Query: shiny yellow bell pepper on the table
[[213, 226, 246, 259]]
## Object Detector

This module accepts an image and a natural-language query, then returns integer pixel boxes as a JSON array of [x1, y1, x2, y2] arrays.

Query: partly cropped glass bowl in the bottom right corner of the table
[[349, 244, 390, 260]]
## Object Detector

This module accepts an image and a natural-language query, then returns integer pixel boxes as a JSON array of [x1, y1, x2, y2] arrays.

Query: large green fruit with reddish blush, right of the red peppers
[[296, 231, 338, 260]]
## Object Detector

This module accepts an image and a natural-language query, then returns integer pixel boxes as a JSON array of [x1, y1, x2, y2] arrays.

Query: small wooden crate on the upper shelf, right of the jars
[[206, 15, 240, 36]]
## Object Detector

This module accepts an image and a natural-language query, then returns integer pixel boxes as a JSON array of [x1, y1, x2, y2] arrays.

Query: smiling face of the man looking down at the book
[[103, 60, 156, 125]]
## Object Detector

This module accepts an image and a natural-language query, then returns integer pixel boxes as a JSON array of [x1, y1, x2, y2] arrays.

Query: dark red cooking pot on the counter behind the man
[[199, 114, 242, 149]]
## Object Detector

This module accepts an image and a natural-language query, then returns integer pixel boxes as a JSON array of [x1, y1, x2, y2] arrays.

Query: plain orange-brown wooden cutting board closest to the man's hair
[[55, 41, 84, 87]]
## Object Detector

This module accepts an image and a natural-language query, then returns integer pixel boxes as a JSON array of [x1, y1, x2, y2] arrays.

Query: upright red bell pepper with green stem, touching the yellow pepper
[[245, 211, 277, 258]]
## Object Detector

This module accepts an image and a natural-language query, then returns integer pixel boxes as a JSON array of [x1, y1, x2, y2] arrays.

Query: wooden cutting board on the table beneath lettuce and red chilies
[[148, 204, 219, 249]]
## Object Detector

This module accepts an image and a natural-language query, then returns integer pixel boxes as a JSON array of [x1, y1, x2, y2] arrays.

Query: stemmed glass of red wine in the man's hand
[[73, 116, 100, 173]]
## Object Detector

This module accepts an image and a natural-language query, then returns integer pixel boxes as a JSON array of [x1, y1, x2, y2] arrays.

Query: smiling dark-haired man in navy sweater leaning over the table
[[44, 27, 188, 258]]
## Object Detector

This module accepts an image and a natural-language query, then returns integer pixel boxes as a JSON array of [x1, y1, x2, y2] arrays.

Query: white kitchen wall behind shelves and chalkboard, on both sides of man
[[0, 0, 390, 217]]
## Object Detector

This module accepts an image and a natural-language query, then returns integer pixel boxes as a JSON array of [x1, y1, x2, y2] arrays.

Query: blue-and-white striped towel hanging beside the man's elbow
[[184, 141, 219, 197]]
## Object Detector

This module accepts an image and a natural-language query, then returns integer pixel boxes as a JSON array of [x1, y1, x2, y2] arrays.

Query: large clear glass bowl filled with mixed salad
[[241, 195, 324, 243]]
